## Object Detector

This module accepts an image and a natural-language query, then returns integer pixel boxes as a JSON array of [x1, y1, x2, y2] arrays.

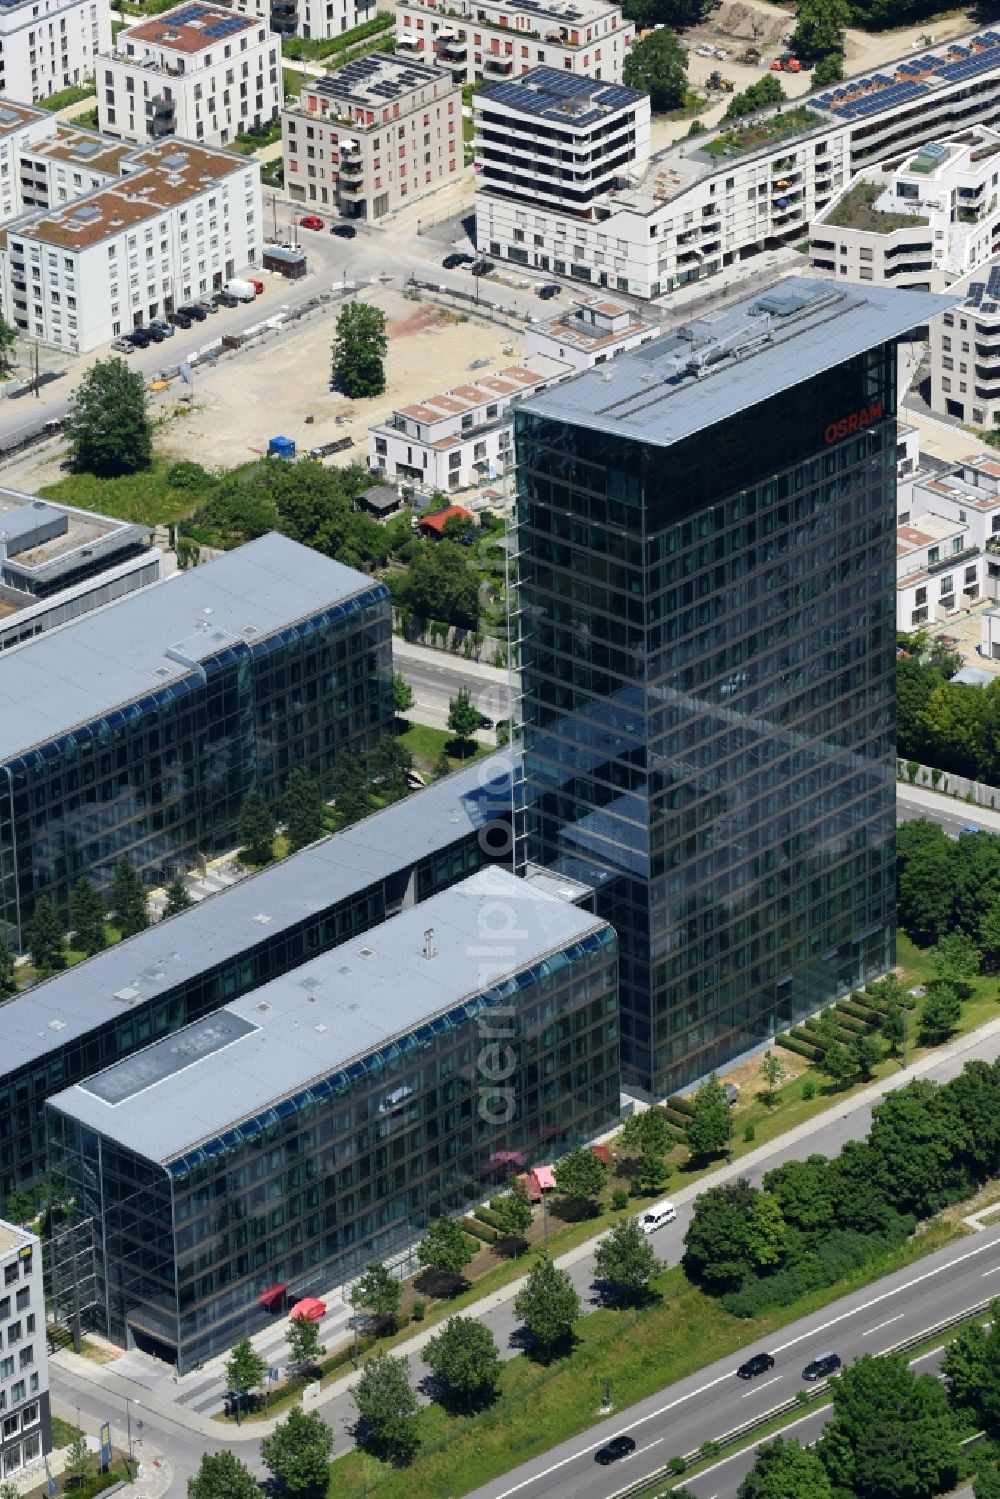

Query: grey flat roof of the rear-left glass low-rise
[[0, 532, 378, 764]]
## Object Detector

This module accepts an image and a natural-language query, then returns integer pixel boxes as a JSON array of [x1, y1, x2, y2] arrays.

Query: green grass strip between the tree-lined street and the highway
[[328, 1220, 966, 1499]]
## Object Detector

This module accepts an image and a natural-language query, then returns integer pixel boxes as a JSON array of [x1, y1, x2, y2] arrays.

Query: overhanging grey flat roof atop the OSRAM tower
[[517, 276, 957, 448]]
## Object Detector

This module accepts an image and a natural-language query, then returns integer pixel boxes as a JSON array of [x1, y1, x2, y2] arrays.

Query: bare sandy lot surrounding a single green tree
[[157, 289, 522, 468]]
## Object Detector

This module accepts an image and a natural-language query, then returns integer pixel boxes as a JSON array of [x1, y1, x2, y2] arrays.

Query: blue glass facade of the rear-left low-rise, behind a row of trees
[[0, 583, 393, 947]]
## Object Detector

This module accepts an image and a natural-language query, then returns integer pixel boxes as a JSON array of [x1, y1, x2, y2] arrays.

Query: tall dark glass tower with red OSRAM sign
[[514, 279, 949, 1094]]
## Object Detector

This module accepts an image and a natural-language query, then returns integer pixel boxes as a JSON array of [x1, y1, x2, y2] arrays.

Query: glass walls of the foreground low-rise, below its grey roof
[[46, 925, 619, 1373]]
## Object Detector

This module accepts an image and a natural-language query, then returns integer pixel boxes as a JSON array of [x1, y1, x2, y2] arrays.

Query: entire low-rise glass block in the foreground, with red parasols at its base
[[46, 868, 621, 1373]]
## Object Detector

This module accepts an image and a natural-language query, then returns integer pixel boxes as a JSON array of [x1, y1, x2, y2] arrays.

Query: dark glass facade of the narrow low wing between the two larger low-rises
[[0, 791, 510, 1198]]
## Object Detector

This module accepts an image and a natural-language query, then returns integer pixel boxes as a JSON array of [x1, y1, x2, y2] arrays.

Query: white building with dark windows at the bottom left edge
[[0, 1219, 52, 1481]]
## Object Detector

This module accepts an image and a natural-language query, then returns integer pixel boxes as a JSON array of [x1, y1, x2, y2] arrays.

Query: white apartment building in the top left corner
[[0, 0, 111, 103]]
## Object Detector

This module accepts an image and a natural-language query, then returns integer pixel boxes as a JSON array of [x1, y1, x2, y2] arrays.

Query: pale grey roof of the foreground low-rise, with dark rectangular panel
[[49, 868, 607, 1163]]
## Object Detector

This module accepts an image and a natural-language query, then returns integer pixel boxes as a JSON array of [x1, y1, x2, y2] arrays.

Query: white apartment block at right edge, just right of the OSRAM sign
[[930, 259, 1000, 427]]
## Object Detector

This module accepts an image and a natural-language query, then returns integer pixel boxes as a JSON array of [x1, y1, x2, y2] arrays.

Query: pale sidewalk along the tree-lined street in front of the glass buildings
[[51, 1016, 1000, 1445]]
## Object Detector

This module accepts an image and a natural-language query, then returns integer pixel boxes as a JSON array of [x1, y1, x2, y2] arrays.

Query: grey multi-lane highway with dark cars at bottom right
[[475, 1228, 1000, 1499]]
